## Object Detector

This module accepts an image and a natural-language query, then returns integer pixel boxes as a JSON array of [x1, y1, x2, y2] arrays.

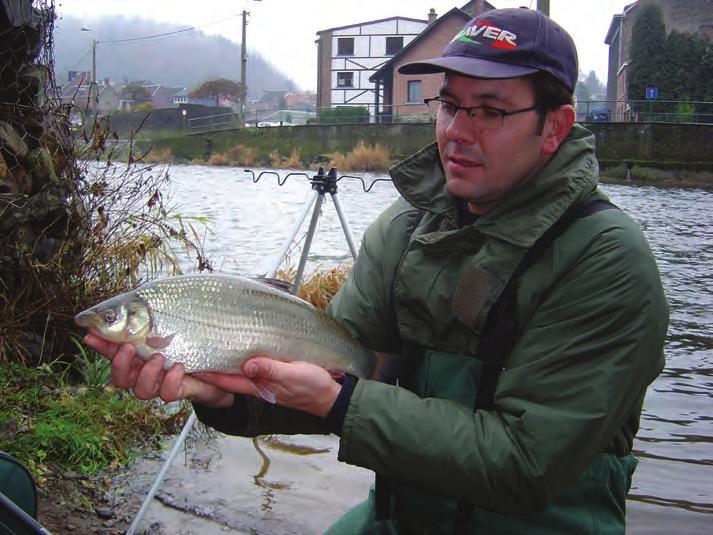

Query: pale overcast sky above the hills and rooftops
[[57, 0, 632, 90]]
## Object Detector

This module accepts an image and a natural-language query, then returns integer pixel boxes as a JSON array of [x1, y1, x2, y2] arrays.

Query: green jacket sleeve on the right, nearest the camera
[[339, 210, 668, 513]]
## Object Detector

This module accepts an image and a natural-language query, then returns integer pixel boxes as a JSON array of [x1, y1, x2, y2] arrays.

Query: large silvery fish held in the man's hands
[[74, 274, 378, 401]]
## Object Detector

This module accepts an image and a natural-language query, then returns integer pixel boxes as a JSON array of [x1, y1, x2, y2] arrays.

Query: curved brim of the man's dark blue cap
[[398, 56, 537, 78]]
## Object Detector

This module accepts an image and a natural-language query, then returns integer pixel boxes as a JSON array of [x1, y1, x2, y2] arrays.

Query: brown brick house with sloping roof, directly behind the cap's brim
[[370, 0, 495, 120]]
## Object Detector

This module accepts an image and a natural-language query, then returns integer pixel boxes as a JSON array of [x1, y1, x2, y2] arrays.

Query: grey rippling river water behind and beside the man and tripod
[[124, 165, 713, 534]]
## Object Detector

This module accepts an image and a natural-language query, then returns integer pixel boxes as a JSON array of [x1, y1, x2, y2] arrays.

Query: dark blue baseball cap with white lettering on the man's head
[[398, 8, 579, 93]]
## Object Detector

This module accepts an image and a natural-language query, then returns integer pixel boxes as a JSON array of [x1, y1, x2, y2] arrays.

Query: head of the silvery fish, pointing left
[[74, 292, 152, 344]]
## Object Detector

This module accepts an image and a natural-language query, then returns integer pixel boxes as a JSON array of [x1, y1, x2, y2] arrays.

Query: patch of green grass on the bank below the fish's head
[[0, 361, 186, 486]]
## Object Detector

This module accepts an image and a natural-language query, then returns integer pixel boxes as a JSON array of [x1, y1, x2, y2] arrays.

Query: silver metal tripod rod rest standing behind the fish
[[126, 167, 357, 535]]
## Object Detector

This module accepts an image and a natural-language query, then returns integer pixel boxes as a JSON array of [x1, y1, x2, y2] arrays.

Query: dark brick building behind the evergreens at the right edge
[[604, 0, 713, 117]]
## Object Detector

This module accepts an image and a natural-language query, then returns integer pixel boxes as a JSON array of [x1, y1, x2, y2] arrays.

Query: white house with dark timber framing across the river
[[316, 17, 428, 115]]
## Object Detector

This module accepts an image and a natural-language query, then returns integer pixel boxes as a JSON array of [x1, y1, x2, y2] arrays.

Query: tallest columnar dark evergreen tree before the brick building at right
[[627, 4, 667, 108]]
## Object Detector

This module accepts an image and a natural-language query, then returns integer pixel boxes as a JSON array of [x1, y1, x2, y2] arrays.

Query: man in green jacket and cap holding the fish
[[87, 9, 668, 534]]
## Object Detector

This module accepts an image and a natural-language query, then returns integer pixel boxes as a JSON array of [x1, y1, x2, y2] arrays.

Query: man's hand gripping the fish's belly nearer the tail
[[193, 356, 341, 418]]
